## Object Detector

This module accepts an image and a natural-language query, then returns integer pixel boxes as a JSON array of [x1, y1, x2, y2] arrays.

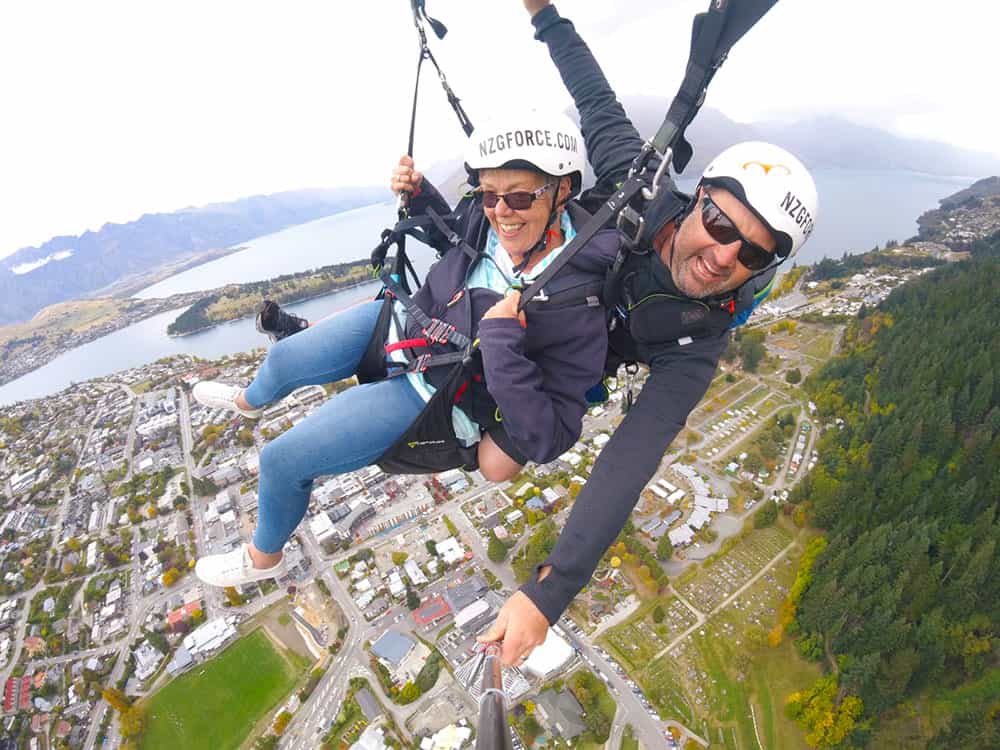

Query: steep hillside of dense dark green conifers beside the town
[[793, 245, 1000, 748]]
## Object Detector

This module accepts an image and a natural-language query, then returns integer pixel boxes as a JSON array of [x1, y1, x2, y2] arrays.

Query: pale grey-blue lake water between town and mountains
[[0, 170, 973, 404]]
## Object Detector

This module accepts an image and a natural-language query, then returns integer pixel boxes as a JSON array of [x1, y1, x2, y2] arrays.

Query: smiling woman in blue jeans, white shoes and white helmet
[[194, 112, 618, 586]]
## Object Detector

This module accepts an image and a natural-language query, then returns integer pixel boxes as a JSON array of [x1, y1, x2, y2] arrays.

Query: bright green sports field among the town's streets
[[140, 630, 307, 750]]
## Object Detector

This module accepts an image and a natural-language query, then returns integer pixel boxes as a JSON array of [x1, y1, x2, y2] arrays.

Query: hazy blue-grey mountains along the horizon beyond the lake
[[0, 106, 1000, 324]]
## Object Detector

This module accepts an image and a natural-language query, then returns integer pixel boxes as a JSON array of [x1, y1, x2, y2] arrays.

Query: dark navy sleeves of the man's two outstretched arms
[[521, 6, 729, 623]]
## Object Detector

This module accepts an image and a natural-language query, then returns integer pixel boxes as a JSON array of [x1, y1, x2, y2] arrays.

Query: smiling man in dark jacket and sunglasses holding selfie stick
[[480, 0, 817, 665]]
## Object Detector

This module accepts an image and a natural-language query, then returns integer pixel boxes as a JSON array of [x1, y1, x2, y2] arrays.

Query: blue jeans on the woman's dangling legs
[[244, 302, 424, 553]]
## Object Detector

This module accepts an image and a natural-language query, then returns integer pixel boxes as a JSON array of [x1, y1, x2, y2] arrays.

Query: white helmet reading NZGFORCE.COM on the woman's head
[[465, 110, 587, 197]]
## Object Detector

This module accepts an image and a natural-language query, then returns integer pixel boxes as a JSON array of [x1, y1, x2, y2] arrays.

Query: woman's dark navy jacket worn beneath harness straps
[[402, 179, 619, 463]]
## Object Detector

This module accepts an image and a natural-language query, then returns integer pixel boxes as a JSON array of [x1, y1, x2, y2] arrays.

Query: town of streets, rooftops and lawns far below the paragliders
[[0, 254, 933, 750]]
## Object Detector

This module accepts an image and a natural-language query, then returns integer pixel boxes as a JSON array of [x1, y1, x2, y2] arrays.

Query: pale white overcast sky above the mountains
[[0, 0, 1000, 257]]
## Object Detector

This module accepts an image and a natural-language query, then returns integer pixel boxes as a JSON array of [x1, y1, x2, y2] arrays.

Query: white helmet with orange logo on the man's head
[[701, 141, 819, 259]]
